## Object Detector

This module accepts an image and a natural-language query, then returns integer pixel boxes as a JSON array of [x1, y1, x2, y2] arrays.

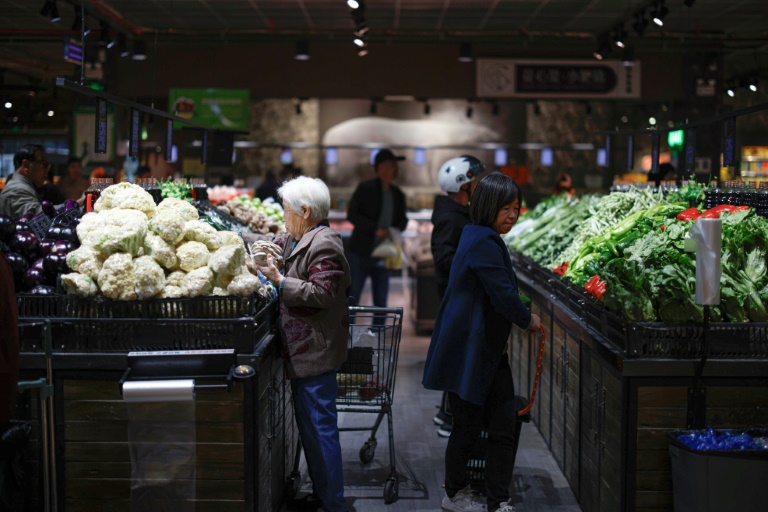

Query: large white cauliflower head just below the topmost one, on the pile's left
[[77, 208, 147, 256]]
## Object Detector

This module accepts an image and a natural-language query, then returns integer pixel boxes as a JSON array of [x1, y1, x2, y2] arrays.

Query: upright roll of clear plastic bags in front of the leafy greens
[[686, 219, 723, 306]]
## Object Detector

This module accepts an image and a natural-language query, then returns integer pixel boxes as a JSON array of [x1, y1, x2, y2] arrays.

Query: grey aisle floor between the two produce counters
[[284, 278, 581, 512]]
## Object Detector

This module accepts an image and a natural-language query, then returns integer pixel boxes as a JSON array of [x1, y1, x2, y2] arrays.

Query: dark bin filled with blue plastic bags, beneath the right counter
[[668, 429, 768, 512]]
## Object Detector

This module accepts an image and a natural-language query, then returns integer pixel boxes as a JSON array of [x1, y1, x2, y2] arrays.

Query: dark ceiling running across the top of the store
[[0, 0, 768, 83]]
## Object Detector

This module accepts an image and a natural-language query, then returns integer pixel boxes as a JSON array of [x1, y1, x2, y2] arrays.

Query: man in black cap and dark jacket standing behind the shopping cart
[[347, 149, 408, 307]]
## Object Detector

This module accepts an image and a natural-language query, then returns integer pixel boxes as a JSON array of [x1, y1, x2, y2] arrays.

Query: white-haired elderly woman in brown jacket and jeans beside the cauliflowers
[[249, 176, 350, 512]]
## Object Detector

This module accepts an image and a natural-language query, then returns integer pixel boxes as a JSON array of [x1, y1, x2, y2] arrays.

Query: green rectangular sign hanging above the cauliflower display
[[168, 89, 250, 131]]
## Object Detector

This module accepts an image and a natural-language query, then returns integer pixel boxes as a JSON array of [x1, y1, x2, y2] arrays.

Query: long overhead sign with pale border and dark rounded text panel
[[477, 59, 640, 98]]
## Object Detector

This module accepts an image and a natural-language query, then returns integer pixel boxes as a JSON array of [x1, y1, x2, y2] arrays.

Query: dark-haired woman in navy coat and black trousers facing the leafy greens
[[422, 172, 541, 512]]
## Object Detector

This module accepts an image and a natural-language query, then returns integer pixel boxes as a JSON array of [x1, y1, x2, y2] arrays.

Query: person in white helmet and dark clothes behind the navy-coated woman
[[431, 155, 485, 437]]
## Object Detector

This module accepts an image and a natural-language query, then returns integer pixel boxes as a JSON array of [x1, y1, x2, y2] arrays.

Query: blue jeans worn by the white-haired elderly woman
[[291, 372, 347, 512]]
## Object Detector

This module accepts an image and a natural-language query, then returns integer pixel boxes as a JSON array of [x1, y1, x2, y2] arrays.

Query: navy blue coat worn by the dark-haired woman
[[422, 224, 531, 405]]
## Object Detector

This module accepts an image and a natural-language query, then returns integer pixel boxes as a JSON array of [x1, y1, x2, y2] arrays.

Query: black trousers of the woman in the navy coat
[[445, 354, 517, 511]]
